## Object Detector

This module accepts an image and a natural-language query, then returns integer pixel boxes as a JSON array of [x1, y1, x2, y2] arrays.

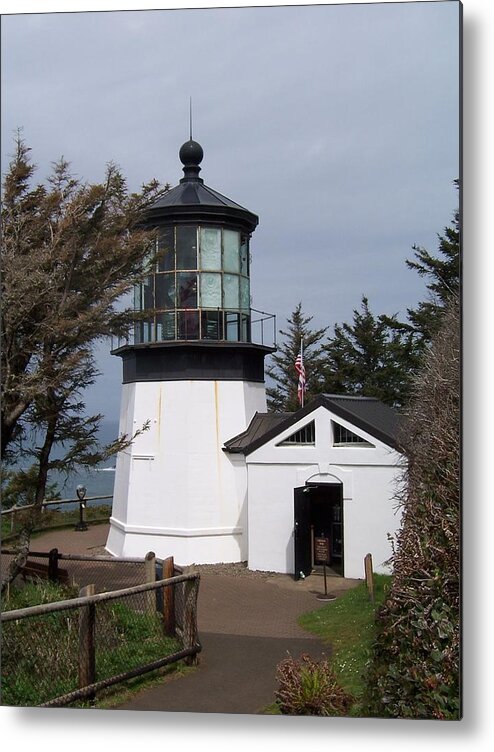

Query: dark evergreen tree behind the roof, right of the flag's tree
[[321, 296, 413, 406]]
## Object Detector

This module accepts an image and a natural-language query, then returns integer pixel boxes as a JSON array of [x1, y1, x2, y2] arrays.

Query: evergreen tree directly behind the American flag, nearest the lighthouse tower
[[266, 303, 327, 412]]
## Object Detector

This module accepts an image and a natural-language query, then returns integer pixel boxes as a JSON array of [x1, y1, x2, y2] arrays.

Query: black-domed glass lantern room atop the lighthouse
[[135, 139, 258, 344]]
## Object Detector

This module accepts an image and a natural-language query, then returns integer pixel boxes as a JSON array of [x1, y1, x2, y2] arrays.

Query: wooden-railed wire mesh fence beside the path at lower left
[[1, 558, 201, 706]]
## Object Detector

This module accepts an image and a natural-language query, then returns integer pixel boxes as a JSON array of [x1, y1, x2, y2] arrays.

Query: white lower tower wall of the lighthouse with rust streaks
[[107, 380, 266, 564]]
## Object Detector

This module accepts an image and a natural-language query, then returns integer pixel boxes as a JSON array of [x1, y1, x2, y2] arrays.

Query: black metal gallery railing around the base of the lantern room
[[112, 308, 276, 350]]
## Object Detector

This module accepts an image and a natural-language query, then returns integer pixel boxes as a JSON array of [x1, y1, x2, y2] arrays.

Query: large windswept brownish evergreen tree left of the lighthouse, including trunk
[[1, 138, 168, 587]]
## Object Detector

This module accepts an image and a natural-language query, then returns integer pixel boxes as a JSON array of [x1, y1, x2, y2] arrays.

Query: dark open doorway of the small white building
[[295, 483, 343, 580]]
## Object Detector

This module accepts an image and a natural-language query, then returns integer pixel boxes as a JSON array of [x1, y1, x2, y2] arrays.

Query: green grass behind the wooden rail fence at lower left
[[2, 581, 182, 707]]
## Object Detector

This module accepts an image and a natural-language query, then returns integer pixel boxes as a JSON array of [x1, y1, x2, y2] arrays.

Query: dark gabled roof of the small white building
[[224, 394, 401, 455]]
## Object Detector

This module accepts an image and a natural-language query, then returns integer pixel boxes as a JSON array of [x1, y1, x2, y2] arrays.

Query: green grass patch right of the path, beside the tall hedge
[[299, 575, 391, 715]]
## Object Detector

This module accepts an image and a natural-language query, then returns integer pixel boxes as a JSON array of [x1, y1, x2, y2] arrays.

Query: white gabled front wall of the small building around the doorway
[[246, 407, 401, 578]]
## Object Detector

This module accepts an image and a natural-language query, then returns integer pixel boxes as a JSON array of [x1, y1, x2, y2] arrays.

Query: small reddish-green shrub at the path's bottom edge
[[275, 653, 353, 716]]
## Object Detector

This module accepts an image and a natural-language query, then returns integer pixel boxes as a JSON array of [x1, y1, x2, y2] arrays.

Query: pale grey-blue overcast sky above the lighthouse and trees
[[1, 0, 459, 419]]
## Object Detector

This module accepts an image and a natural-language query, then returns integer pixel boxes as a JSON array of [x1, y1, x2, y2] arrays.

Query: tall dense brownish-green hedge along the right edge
[[366, 292, 461, 719]]
